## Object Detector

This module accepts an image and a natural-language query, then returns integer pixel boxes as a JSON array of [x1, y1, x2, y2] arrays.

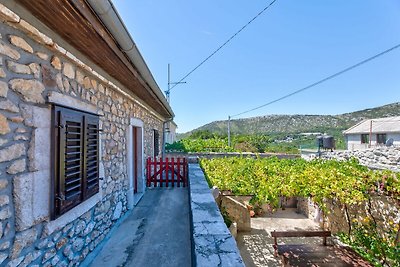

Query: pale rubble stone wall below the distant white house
[[321, 146, 400, 171]]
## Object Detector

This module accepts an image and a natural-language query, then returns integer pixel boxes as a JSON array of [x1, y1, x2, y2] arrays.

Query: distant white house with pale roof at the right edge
[[343, 116, 400, 150]]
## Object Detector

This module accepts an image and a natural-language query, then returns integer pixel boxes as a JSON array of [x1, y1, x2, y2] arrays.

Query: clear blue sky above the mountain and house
[[113, 0, 400, 132]]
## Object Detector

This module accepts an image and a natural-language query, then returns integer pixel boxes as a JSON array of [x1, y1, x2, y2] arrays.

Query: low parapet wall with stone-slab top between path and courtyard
[[189, 164, 244, 267]]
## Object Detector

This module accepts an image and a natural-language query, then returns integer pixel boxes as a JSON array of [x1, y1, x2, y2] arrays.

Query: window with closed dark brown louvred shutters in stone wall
[[51, 106, 99, 219]]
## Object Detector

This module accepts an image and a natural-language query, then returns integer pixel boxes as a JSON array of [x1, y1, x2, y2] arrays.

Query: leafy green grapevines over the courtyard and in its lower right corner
[[201, 157, 400, 266]]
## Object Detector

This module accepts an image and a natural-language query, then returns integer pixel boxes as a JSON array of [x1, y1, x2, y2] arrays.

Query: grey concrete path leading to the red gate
[[89, 187, 191, 267]]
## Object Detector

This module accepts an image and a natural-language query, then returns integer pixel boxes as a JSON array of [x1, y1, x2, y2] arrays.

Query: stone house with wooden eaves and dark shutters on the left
[[0, 0, 174, 266]]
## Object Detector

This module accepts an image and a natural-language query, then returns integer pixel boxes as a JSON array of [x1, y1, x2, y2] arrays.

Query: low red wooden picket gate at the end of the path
[[146, 158, 188, 187]]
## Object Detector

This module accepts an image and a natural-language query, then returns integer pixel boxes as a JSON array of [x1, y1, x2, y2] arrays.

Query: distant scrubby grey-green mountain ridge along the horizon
[[180, 102, 400, 138]]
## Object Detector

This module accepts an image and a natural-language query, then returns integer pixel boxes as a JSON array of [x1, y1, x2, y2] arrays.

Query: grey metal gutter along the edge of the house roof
[[87, 0, 174, 117]]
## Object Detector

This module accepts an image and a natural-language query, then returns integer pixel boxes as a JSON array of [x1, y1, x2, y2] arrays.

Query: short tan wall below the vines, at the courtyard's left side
[[221, 195, 251, 231]]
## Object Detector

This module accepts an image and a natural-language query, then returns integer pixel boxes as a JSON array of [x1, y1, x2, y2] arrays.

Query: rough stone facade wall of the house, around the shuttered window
[[0, 5, 162, 266]]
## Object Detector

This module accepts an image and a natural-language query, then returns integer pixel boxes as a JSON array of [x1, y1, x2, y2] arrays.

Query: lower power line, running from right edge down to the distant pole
[[230, 44, 400, 118]]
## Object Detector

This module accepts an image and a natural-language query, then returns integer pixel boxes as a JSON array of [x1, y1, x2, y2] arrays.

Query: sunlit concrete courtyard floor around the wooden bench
[[237, 208, 322, 267]]
